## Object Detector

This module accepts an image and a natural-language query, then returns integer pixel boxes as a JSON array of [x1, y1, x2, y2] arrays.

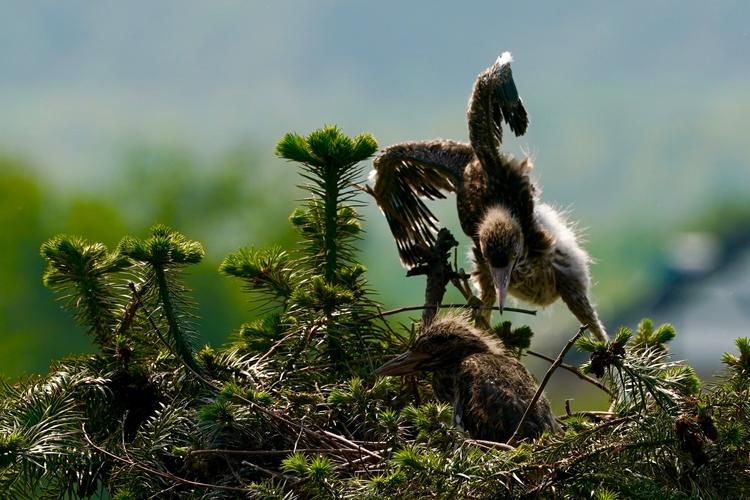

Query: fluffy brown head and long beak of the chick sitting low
[[375, 315, 502, 375]]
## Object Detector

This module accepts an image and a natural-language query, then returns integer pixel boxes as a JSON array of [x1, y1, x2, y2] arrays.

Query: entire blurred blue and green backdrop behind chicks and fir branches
[[0, 0, 750, 406]]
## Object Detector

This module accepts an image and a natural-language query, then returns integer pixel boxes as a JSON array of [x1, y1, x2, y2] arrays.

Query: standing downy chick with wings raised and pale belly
[[369, 52, 607, 340]]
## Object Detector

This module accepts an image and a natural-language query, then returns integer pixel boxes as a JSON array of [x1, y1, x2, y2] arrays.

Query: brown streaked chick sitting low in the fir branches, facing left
[[375, 315, 559, 442]]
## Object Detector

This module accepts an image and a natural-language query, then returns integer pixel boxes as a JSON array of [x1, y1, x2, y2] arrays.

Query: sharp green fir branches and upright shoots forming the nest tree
[[0, 128, 750, 499]]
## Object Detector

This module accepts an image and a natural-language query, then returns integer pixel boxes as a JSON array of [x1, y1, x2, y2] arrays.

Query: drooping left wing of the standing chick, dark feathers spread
[[369, 140, 475, 268]]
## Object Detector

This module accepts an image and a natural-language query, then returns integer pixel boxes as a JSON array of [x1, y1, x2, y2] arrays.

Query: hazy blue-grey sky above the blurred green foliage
[[0, 0, 750, 376]]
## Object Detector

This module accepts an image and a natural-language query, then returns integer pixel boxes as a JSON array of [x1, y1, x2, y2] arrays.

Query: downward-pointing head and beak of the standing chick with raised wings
[[478, 206, 524, 314]]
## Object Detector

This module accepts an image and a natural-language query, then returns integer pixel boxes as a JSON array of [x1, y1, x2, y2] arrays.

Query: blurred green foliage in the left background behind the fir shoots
[[0, 148, 294, 377]]
